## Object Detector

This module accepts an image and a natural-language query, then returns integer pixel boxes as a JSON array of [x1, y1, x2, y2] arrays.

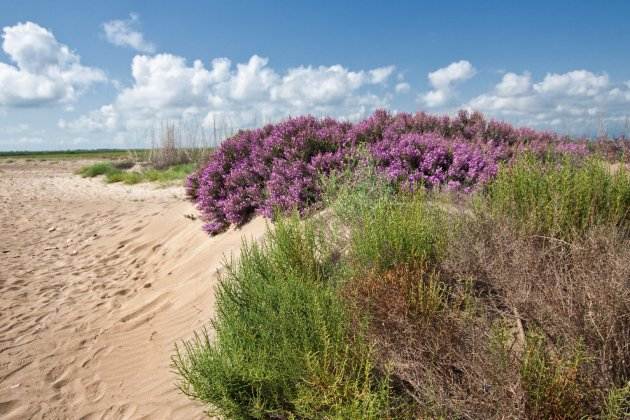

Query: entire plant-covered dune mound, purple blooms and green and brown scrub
[[173, 112, 630, 419]]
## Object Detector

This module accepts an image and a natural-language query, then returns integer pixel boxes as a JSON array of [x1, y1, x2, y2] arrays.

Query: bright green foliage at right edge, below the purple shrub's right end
[[481, 156, 630, 239]]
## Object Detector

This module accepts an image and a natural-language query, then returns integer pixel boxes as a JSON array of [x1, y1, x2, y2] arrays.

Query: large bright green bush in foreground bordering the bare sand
[[174, 219, 398, 418]]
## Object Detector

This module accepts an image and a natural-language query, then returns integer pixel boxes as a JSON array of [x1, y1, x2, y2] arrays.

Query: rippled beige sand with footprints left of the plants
[[0, 160, 265, 419]]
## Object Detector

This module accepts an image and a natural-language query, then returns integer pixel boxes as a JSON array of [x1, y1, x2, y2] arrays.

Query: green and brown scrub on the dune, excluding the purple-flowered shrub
[[173, 146, 630, 419]]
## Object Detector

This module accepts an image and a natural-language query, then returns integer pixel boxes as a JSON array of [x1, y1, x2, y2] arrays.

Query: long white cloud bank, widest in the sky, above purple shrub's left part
[[59, 54, 394, 137]]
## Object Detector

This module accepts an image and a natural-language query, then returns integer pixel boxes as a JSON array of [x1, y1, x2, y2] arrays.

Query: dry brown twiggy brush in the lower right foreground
[[344, 212, 630, 419]]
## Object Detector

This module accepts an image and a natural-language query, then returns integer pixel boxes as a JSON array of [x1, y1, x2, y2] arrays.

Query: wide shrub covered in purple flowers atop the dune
[[193, 110, 616, 234]]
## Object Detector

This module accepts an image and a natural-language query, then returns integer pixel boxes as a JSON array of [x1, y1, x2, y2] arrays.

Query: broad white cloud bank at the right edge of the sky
[[466, 70, 630, 134]]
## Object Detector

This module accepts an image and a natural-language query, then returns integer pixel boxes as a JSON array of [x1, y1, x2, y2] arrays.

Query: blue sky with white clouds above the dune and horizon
[[0, 0, 630, 150]]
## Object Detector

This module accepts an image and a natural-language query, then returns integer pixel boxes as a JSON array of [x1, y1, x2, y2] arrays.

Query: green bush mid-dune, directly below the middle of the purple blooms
[[325, 164, 448, 273]]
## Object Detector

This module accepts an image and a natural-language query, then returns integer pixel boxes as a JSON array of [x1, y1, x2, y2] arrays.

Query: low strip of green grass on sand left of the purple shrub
[[77, 162, 196, 185]]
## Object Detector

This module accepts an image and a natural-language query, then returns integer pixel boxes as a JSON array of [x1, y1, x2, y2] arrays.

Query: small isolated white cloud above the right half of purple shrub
[[420, 60, 476, 107]]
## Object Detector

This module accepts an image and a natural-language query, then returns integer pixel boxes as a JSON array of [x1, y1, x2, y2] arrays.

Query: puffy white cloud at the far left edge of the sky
[[0, 22, 106, 107]]
